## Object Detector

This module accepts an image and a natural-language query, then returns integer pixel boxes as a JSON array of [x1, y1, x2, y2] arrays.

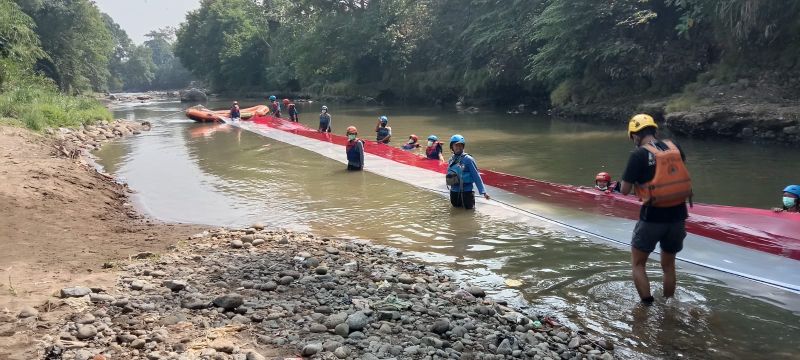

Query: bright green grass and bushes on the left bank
[[0, 0, 111, 130]]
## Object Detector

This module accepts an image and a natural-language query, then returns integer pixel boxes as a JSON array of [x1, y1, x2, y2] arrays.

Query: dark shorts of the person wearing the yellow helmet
[[631, 220, 686, 254]]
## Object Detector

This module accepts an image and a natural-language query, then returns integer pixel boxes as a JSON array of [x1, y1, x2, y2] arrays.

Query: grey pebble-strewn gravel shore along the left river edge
[[0, 120, 614, 360]]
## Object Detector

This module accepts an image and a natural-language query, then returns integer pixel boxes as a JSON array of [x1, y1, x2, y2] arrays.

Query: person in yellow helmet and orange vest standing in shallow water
[[621, 114, 692, 306]]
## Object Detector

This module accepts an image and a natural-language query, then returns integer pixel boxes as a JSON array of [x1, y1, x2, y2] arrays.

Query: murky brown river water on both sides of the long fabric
[[96, 102, 800, 359]]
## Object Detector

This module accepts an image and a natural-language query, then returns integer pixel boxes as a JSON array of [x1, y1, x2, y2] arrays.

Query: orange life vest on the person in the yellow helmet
[[636, 140, 692, 207]]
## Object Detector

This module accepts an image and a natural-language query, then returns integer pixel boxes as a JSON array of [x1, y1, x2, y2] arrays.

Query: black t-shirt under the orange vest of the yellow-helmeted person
[[622, 140, 689, 223]]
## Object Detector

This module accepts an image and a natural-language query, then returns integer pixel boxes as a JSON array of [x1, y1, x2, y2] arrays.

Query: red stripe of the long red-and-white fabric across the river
[[252, 116, 800, 260]]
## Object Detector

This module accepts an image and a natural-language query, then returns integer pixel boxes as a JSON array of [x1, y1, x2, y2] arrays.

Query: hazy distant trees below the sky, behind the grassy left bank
[[5, 0, 191, 94]]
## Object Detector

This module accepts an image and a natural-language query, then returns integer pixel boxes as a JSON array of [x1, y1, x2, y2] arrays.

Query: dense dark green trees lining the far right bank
[[176, 0, 800, 104]]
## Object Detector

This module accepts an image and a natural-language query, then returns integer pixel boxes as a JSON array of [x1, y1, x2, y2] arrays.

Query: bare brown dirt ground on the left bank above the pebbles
[[0, 127, 201, 358]]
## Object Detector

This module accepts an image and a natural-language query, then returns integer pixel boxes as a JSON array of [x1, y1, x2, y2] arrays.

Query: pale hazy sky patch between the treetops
[[94, 0, 200, 44]]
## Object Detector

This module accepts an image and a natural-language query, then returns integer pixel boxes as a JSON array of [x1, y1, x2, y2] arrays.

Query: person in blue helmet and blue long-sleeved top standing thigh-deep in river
[[445, 134, 491, 209]]
